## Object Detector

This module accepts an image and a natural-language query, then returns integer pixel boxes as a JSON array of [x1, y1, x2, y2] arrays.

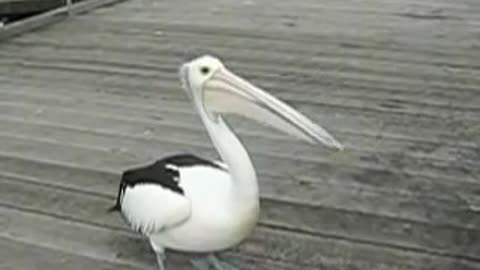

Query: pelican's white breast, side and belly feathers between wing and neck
[[150, 166, 259, 252]]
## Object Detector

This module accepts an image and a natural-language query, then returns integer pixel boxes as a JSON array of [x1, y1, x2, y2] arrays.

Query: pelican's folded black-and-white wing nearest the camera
[[112, 159, 191, 235]]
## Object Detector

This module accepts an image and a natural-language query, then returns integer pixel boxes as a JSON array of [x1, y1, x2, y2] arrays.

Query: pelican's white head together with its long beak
[[180, 55, 343, 149]]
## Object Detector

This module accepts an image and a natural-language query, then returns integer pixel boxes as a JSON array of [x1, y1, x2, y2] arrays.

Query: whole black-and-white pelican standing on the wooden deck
[[112, 55, 342, 270]]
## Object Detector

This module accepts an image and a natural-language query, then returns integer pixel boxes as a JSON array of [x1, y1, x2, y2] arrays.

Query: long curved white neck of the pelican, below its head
[[193, 93, 258, 202]]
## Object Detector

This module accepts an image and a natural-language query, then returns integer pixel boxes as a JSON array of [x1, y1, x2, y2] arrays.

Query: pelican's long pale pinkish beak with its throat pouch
[[203, 67, 343, 149]]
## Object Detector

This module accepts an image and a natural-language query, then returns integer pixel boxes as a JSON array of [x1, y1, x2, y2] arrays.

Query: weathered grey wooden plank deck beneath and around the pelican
[[0, 0, 480, 270]]
